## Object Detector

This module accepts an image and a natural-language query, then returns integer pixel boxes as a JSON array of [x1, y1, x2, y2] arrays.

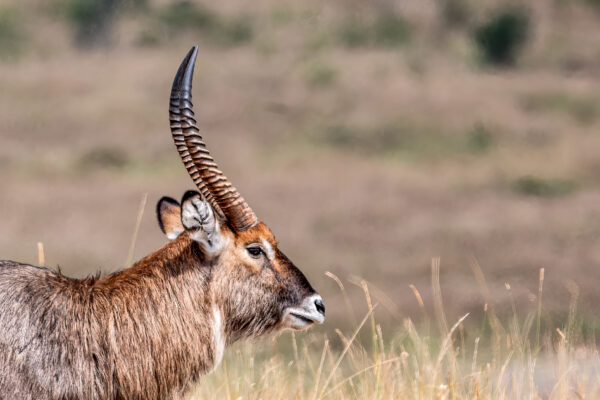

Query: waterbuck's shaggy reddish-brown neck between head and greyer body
[[95, 234, 225, 397]]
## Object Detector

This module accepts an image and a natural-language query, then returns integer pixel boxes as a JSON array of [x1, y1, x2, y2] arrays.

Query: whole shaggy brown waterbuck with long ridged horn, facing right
[[0, 47, 325, 400]]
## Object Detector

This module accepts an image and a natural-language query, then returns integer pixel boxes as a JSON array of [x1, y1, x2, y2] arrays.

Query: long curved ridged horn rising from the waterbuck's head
[[169, 46, 258, 231]]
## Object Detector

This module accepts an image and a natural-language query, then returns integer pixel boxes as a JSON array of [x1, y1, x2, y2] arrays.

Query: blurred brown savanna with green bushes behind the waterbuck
[[0, 0, 600, 330]]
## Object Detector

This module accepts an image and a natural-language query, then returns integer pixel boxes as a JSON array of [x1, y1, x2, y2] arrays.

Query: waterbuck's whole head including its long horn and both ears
[[157, 47, 325, 343]]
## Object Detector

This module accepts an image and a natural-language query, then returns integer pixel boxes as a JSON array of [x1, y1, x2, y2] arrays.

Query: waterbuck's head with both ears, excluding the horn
[[157, 194, 325, 341]]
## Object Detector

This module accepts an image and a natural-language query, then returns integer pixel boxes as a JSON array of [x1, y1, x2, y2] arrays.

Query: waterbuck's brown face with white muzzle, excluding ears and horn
[[214, 223, 325, 336]]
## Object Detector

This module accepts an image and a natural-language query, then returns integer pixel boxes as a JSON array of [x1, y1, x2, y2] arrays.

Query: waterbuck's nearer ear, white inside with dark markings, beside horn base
[[181, 196, 225, 255]]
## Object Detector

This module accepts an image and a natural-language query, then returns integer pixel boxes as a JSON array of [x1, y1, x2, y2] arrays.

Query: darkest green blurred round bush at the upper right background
[[474, 8, 529, 66]]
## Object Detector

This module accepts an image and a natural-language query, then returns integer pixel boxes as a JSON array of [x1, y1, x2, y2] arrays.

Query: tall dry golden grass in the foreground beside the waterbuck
[[187, 259, 600, 400]]
